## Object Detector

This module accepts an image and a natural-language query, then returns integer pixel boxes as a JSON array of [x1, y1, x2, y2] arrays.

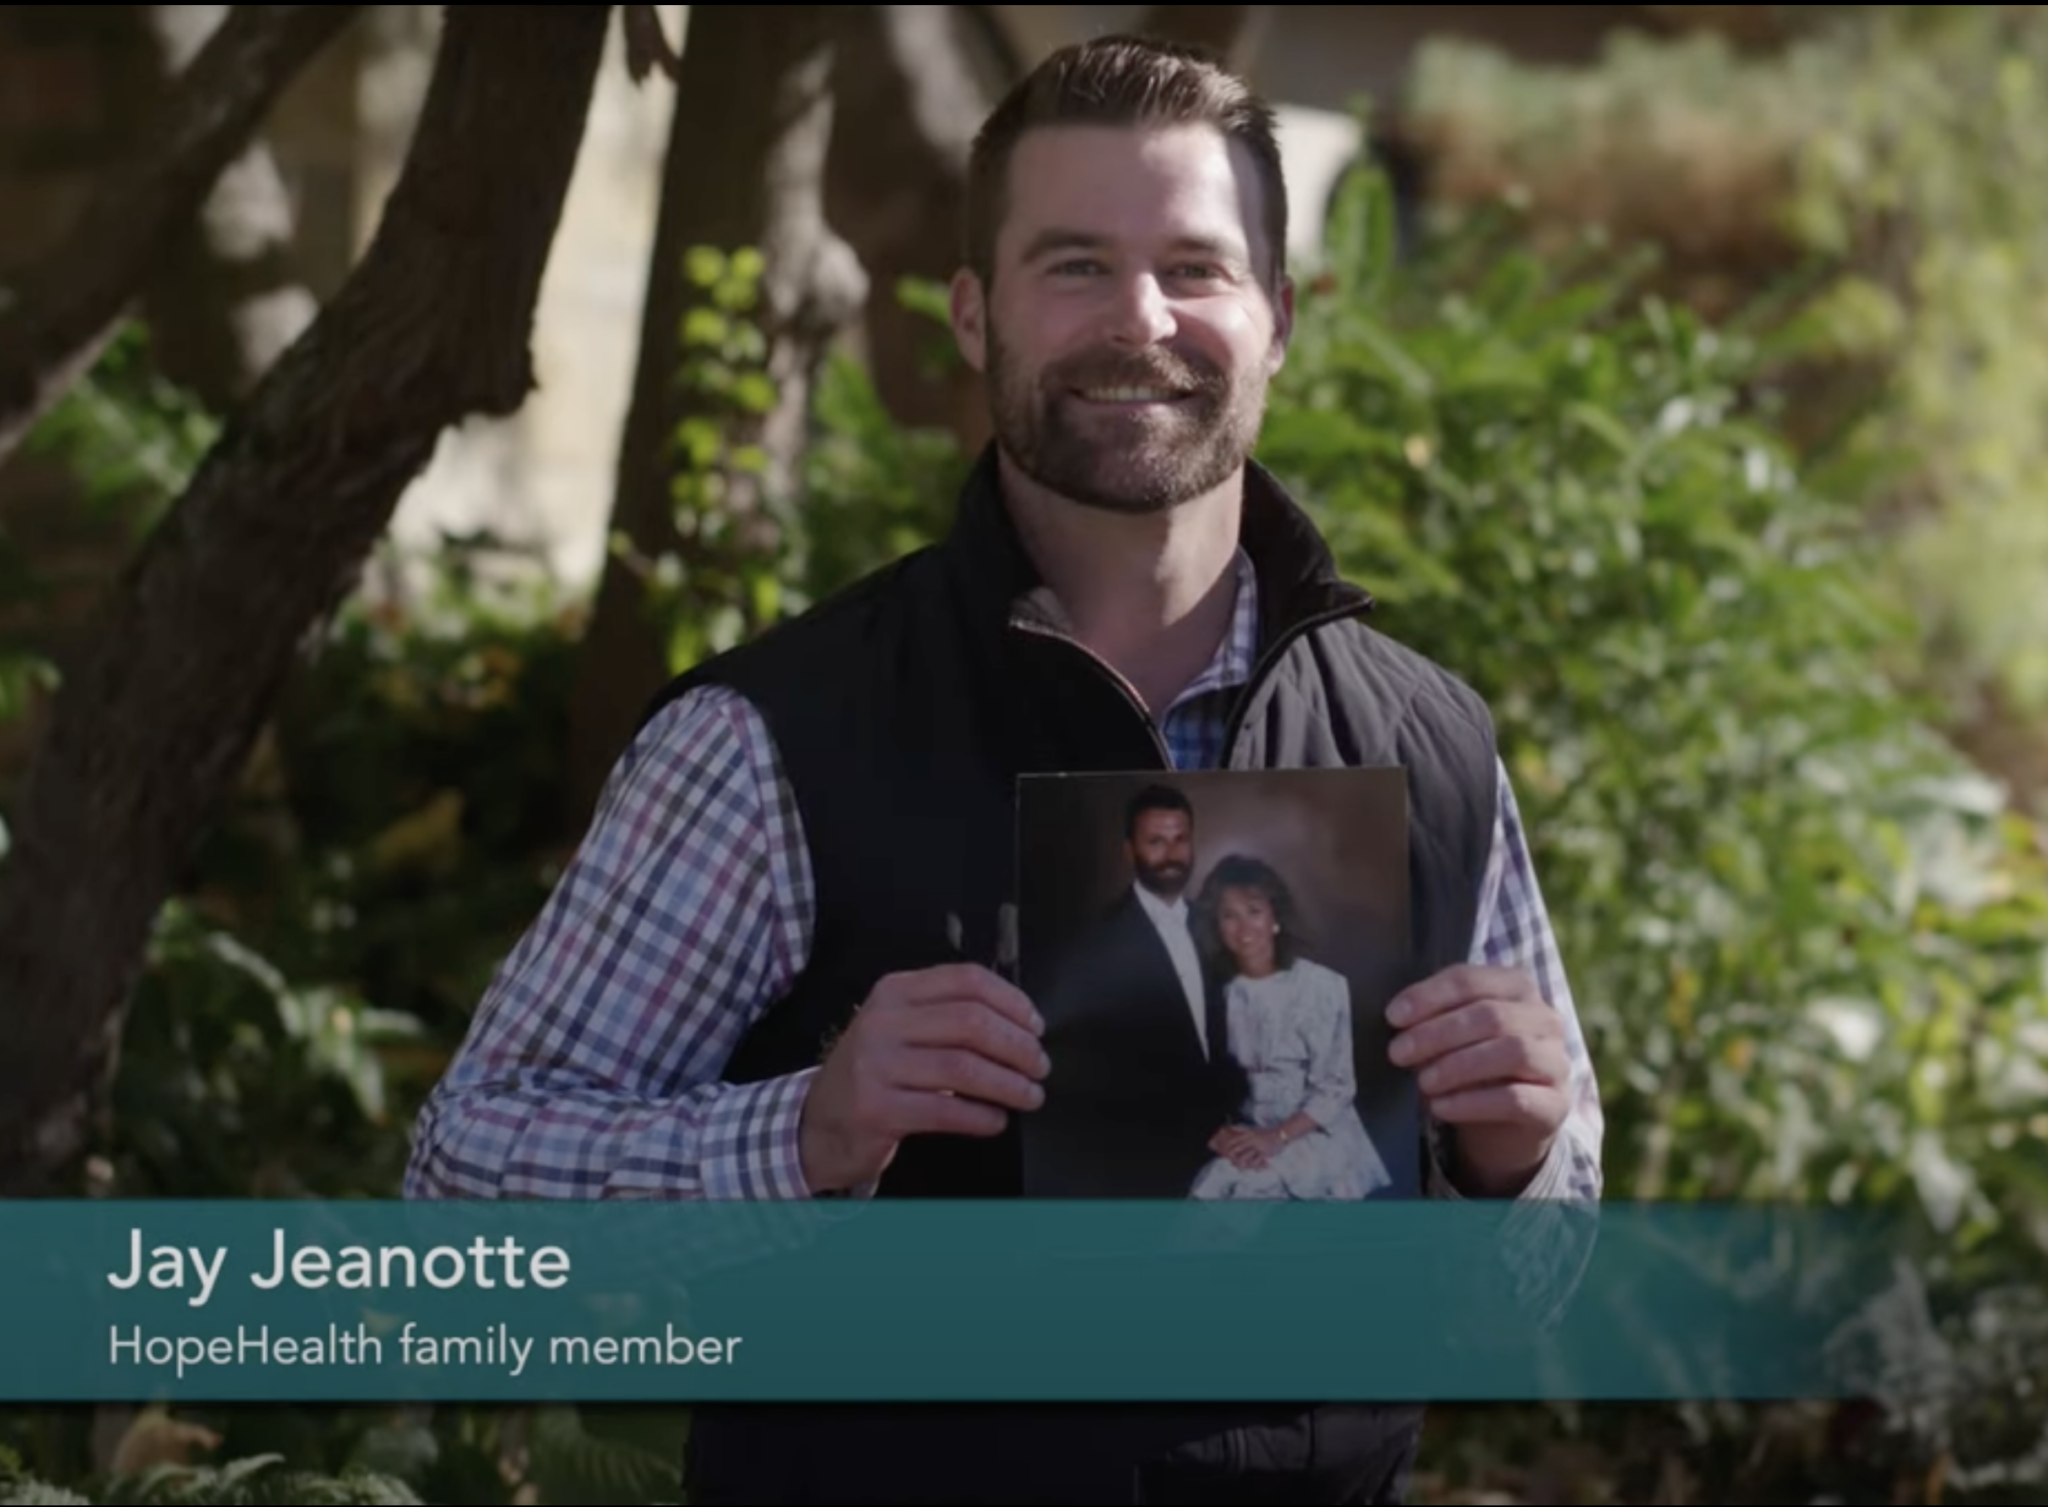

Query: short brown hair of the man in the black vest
[[967, 35, 1286, 287]]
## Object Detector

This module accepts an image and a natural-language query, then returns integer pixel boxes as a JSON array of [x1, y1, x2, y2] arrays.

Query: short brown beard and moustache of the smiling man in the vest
[[989, 330, 1266, 514]]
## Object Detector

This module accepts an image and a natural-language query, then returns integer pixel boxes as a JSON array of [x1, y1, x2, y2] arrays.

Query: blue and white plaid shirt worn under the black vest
[[406, 551, 1604, 1304]]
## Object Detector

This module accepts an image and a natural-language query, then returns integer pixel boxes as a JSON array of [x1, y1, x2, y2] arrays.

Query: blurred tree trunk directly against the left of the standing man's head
[[825, 6, 1010, 453]]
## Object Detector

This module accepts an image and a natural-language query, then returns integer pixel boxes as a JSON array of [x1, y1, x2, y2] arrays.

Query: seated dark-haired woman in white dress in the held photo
[[1188, 854, 1393, 1198]]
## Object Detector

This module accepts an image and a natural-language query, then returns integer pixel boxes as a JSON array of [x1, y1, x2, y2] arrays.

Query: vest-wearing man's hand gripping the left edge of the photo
[[799, 962, 1051, 1194]]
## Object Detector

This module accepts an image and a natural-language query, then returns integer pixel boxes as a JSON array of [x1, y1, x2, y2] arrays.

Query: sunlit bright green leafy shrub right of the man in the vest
[[1262, 164, 2048, 1501]]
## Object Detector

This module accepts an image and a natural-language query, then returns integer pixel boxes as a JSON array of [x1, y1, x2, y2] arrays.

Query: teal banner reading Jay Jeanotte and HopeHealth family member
[[0, 1200, 1911, 1403]]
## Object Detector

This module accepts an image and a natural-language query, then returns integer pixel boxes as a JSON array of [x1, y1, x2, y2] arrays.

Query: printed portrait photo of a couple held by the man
[[1020, 770, 1421, 1200]]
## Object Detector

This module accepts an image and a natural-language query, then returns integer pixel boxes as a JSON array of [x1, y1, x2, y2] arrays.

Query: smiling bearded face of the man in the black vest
[[954, 125, 1292, 512]]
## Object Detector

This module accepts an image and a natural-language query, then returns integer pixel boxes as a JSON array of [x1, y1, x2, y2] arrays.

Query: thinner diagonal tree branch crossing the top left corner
[[0, 6, 360, 472]]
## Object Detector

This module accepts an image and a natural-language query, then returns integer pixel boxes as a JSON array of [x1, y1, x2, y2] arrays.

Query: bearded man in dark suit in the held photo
[[1024, 784, 1241, 1198]]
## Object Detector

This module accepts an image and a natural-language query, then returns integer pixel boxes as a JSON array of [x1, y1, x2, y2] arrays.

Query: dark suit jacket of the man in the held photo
[[1024, 893, 1237, 1198]]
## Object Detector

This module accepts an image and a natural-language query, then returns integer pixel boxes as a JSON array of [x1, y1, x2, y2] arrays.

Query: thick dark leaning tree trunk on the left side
[[0, 6, 610, 1196]]
